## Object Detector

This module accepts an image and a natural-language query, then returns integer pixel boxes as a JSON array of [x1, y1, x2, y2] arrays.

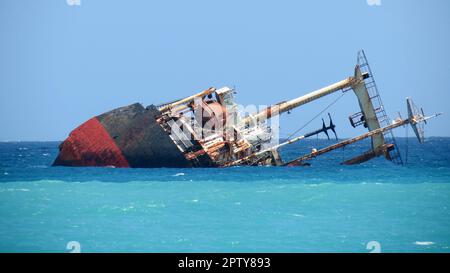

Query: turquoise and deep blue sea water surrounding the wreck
[[0, 138, 450, 253]]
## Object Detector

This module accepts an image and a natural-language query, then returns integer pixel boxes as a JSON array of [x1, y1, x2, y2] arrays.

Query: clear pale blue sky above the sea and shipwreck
[[0, 0, 450, 141]]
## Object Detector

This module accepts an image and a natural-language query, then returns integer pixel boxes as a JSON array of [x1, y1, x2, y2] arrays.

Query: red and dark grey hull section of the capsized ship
[[53, 103, 200, 168]]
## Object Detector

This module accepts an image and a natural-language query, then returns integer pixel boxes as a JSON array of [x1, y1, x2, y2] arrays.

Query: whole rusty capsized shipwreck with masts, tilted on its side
[[53, 51, 439, 168]]
